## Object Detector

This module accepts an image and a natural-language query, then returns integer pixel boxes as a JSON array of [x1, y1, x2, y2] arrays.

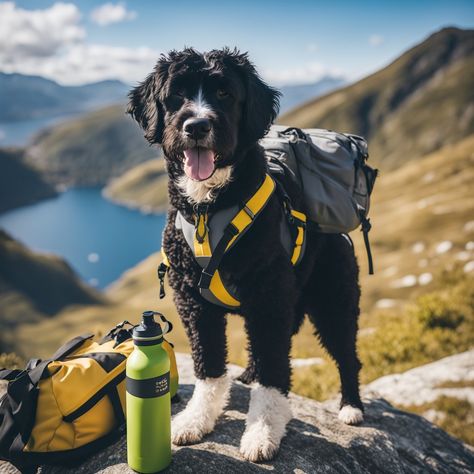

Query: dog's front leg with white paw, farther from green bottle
[[240, 260, 296, 462]]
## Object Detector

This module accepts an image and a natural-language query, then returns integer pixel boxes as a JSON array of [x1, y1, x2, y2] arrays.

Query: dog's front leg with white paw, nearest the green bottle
[[171, 293, 230, 445]]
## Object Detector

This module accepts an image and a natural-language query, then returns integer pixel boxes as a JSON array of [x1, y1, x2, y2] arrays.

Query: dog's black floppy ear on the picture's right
[[232, 54, 281, 145]]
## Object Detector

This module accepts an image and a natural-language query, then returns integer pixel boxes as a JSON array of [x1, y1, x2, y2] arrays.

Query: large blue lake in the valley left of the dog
[[0, 188, 166, 288]]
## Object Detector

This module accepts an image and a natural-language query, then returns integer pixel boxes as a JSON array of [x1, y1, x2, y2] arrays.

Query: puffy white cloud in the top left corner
[[0, 2, 85, 62]]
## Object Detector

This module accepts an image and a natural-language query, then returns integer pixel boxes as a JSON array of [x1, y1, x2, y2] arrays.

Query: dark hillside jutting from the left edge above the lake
[[0, 149, 56, 212]]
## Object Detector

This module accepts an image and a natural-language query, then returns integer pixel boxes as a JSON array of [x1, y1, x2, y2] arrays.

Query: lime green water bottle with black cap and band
[[126, 311, 171, 473]]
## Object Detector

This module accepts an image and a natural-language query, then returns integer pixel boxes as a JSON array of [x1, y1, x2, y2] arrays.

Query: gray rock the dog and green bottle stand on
[[0, 355, 474, 474]]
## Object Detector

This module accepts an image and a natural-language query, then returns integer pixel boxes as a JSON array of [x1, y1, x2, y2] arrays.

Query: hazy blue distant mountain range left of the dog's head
[[0, 72, 129, 122]]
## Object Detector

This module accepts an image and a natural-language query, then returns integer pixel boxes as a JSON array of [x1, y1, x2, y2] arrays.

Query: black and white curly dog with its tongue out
[[128, 48, 363, 461]]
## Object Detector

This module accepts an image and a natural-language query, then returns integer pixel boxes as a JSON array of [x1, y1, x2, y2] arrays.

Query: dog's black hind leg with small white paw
[[304, 235, 363, 424]]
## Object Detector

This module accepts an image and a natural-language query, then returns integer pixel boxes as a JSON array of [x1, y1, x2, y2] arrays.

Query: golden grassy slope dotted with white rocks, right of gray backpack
[[352, 134, 474, 310]]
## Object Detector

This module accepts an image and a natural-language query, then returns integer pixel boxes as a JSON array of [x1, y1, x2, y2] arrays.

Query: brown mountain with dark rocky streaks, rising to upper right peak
[[279, 28, 474, 169]]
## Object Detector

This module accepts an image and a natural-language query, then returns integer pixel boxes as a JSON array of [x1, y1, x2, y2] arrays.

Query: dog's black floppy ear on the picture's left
[[127, 57, 170, 144]]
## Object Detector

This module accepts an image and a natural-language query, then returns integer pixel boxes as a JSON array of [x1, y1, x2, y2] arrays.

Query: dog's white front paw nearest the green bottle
[[171, 375, 230, 445]]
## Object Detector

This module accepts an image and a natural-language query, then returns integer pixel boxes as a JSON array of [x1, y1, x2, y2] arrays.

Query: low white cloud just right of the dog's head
[[262, 62, 344, 86]]
